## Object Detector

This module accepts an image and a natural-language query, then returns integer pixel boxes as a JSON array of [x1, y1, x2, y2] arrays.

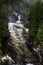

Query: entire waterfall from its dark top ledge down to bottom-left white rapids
[[2, 12, 33, 65]]
